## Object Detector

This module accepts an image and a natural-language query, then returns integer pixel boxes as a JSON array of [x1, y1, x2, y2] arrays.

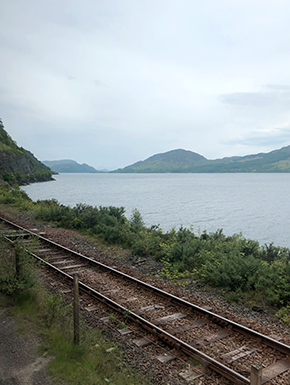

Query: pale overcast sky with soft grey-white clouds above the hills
[[0, 0, 290, 169]]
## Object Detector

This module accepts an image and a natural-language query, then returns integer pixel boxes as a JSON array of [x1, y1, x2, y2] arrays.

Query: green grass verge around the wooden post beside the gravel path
[[0, 237, 150, 385]]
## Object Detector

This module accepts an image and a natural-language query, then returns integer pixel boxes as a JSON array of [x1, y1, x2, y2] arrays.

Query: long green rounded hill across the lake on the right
[[113, 146, 290, 173]]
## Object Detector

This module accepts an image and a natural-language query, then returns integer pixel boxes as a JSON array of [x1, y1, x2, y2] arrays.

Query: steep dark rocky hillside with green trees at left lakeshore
[[0, 119, 52, 184]]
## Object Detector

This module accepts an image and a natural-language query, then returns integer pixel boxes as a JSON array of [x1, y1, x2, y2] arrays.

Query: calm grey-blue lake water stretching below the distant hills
[[22, 174, 290, 247]]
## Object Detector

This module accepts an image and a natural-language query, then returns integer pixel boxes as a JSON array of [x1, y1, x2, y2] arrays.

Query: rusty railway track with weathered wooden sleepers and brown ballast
[[0, 218, 290, 384]]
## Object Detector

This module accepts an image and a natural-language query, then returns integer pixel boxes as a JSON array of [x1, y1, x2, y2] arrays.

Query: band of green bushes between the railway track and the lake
[[0, 185, 290, 322]]
